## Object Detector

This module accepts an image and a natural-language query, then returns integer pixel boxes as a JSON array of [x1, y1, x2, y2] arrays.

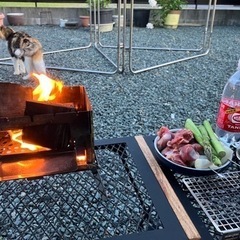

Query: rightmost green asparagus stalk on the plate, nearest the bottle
[[203, 120, 226, 158]]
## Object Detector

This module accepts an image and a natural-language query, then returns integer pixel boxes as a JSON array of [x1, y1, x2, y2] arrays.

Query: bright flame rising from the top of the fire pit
[[33, 73, 63, 101]]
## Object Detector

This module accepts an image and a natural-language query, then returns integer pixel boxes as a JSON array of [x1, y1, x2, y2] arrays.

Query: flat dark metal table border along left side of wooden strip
[[95, 137, 190, 240]]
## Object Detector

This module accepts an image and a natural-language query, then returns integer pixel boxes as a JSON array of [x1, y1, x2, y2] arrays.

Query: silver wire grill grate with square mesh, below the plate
[[183, 171, 240, 239]]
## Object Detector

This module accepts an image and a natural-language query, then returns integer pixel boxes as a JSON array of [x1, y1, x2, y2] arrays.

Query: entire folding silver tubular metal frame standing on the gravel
[[0, 0, 217, 74]]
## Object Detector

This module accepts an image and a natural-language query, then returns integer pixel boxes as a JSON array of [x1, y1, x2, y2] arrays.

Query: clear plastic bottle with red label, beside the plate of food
[[215, 61, 240, 145]]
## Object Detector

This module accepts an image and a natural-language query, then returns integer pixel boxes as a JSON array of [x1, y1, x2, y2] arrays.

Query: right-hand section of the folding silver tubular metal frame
[[129, 0, 217, 73]]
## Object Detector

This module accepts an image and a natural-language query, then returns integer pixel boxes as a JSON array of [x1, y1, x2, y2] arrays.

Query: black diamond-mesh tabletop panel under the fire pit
[[0, 143, 163, 240]]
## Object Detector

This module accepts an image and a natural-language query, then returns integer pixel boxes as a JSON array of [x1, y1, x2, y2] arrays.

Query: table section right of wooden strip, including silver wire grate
[[142, 137, 240, 240]]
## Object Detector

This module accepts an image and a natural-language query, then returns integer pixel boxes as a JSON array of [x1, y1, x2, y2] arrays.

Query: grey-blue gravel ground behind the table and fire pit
[[0, 26, 240, 139]]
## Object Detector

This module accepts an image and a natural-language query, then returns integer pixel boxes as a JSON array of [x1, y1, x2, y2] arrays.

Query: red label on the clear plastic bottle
[[217, 99, 240, 132]]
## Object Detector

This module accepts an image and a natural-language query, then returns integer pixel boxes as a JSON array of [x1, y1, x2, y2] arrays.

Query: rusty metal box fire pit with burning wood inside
[[0, 75, 96, 181]]
